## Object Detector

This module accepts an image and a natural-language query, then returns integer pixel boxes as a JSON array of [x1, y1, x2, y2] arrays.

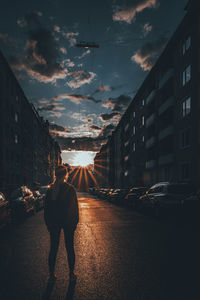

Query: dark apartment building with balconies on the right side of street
[[94, 0, 200, 187]]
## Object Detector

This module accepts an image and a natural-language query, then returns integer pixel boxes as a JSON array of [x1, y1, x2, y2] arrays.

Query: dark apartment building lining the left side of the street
[[0, 52, 61, 191]]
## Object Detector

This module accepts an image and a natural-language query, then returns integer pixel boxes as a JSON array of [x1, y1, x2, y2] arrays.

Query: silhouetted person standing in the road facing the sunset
[[44, 166, 79, 281]]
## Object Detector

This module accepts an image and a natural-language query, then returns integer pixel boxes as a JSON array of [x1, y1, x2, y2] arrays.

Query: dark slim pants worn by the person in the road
[[49, 228, 75, 274]]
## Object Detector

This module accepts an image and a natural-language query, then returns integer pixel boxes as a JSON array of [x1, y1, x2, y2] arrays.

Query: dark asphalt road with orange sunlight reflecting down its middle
[[0, 193, 200, 300]]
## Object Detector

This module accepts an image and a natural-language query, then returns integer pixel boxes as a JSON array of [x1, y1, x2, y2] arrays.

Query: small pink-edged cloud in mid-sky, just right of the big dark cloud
[[67, 70, 96, 89]]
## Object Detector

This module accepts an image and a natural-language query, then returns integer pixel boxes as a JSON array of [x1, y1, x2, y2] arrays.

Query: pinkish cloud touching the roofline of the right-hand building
[[131, 37, 166, 71]]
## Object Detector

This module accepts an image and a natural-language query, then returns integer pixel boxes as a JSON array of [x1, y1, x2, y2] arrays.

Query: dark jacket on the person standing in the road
[[44, 182, 79, 231]]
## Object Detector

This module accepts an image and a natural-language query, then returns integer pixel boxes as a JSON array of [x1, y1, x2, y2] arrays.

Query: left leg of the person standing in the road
[[49, 229, 61, 276]]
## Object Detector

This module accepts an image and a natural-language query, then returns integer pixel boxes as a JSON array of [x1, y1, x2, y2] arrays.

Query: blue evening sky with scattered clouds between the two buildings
[[0, 0, 188, 164]]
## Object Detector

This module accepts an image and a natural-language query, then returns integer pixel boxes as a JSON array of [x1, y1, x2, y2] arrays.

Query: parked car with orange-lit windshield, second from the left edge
[[10, 185, 35, 218]]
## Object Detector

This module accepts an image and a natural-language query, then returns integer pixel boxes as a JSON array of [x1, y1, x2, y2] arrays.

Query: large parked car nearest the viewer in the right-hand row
[[138, 182, 194, 217]]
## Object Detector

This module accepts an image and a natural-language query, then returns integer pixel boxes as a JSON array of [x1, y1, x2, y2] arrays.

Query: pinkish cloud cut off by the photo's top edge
[[113, 0, 157, 24]]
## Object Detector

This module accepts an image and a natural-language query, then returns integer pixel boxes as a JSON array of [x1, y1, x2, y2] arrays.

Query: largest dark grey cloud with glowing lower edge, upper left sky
[[11, 12, 67, 82]]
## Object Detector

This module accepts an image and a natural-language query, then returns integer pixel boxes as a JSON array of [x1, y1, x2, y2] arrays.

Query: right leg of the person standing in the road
[[64, 229, 75, 274]]
